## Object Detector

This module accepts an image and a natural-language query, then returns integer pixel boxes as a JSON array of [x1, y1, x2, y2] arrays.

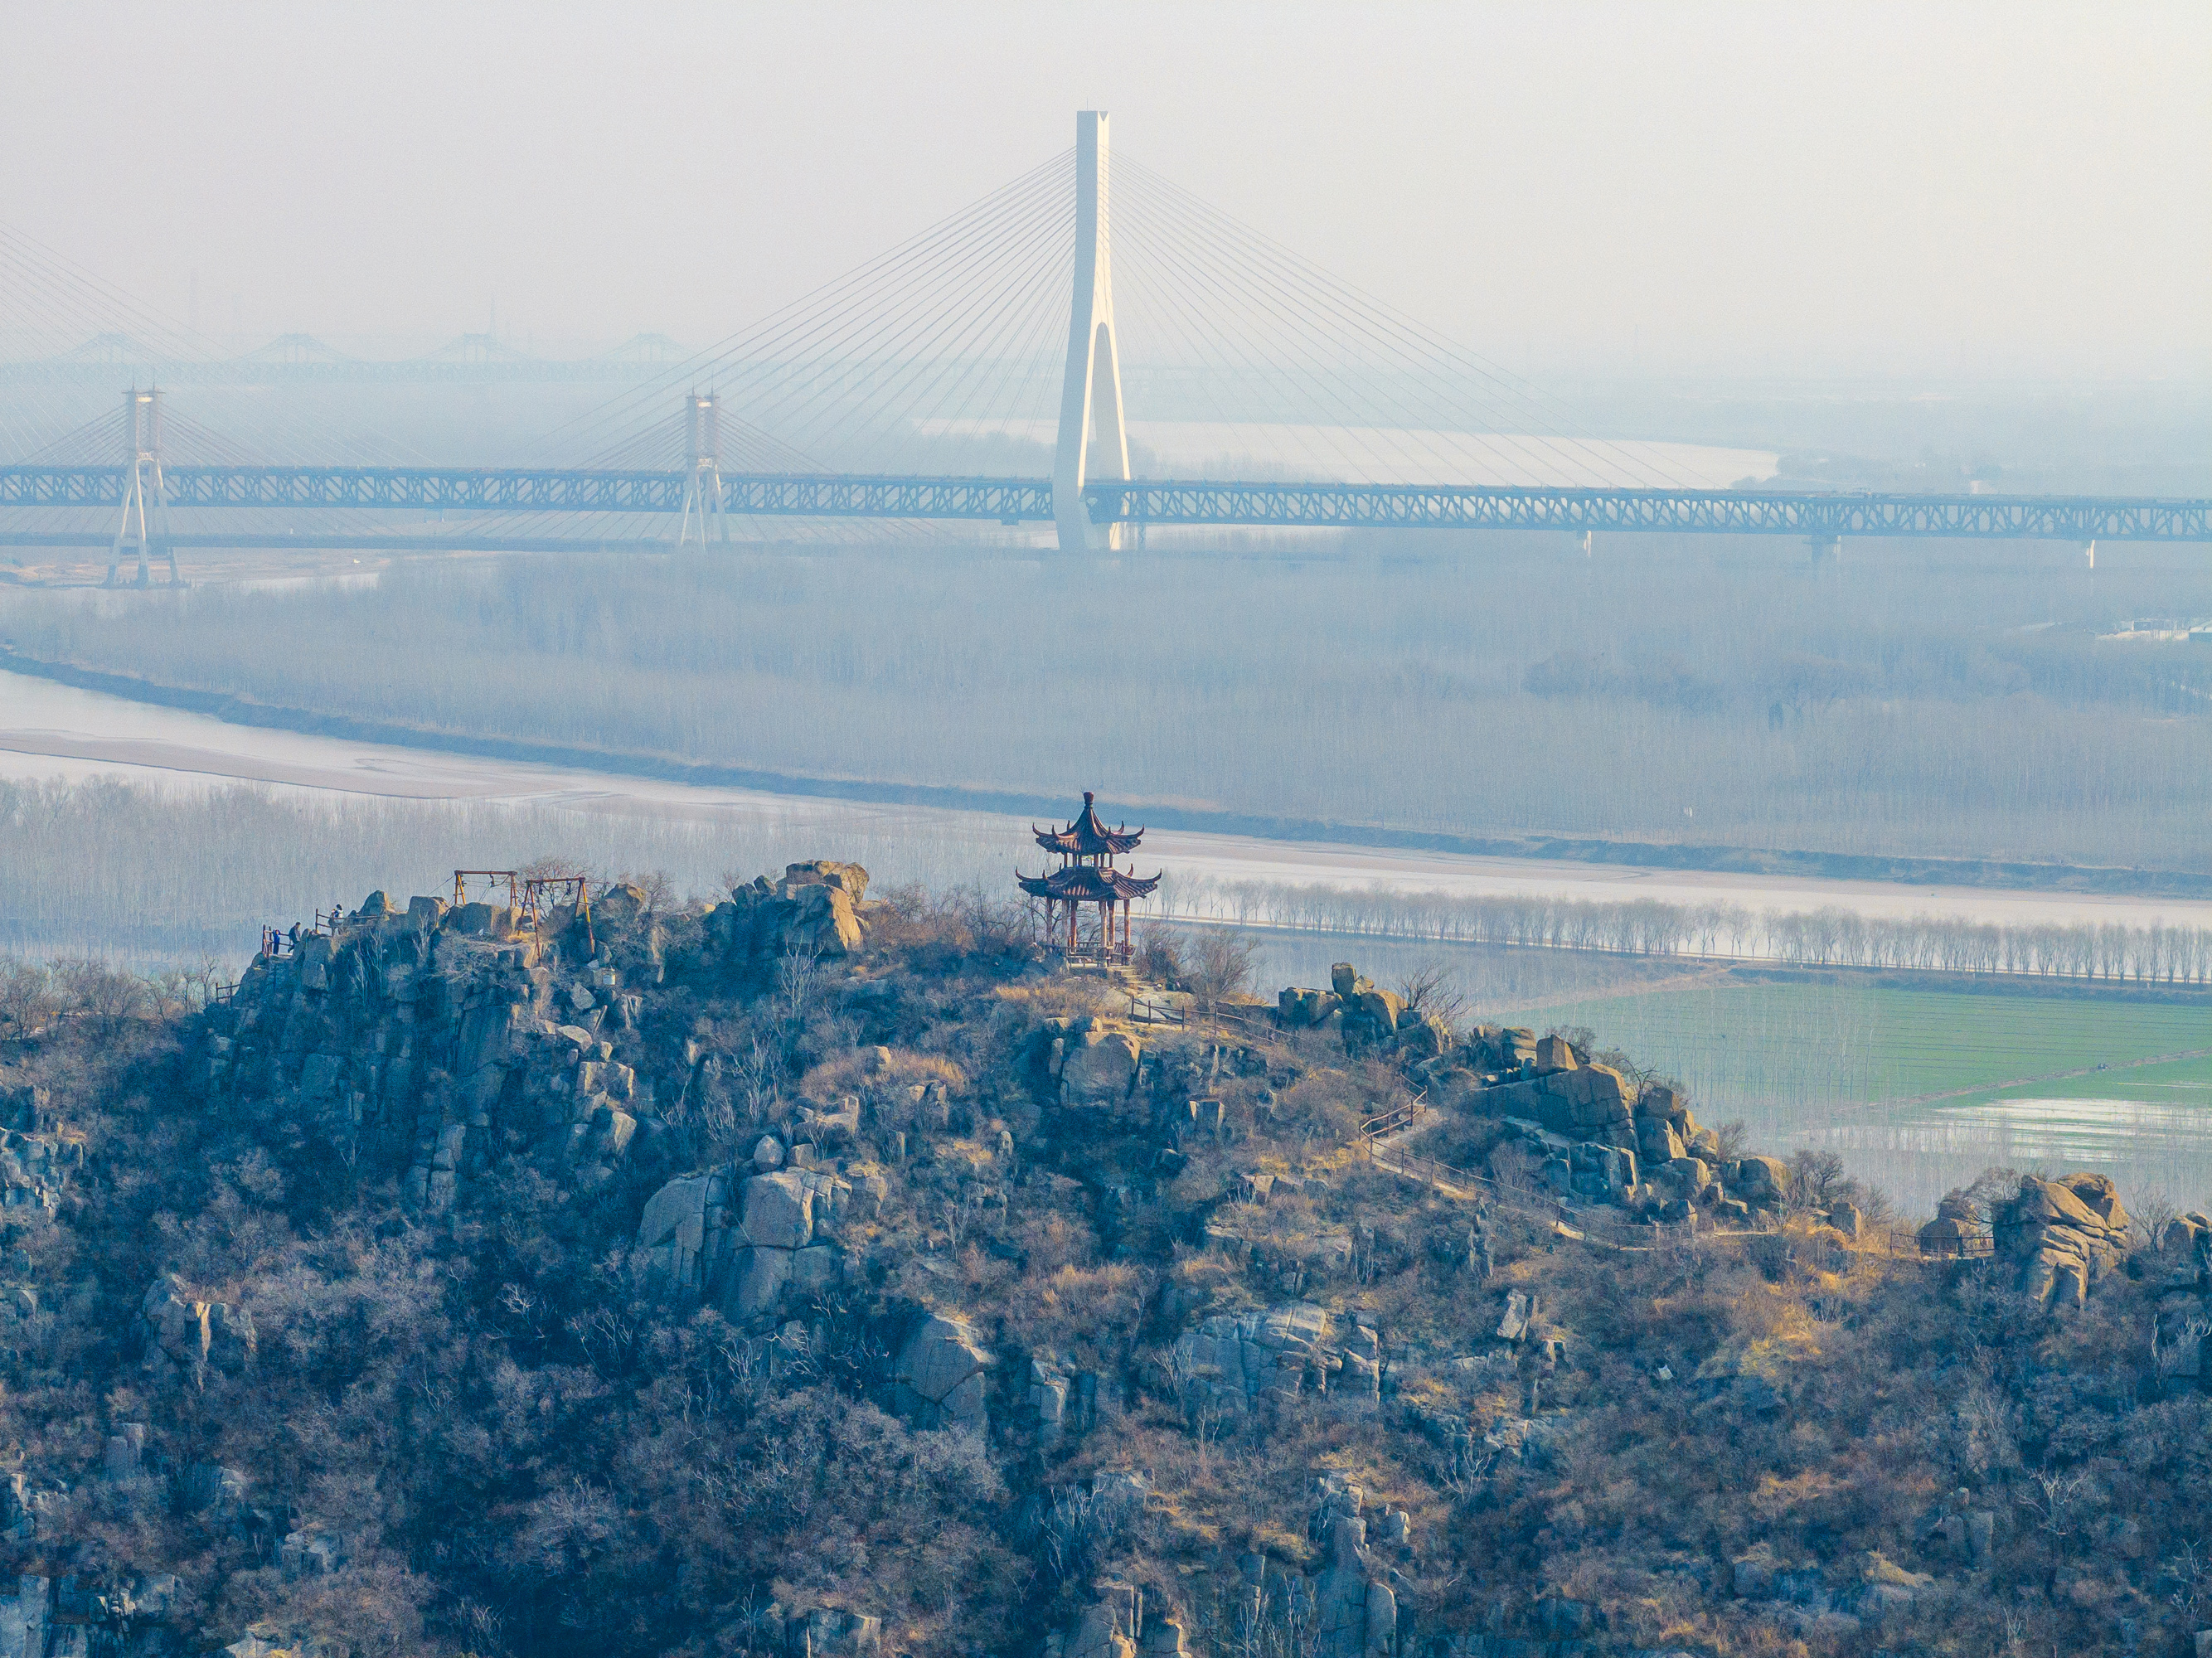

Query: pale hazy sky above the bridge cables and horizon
[[0, 0, 2212, 378]]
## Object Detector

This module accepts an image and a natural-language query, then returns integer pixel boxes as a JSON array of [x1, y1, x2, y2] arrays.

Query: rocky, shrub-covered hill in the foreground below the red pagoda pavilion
[[0, 862, 2212, 1658]]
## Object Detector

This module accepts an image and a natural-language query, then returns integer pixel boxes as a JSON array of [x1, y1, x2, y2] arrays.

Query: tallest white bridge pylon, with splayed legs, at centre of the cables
[[1053, 109, 1128, 553]]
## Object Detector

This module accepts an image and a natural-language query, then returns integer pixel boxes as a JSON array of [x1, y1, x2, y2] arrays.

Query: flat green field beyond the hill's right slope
[[1509, 982, 2212, 1207]]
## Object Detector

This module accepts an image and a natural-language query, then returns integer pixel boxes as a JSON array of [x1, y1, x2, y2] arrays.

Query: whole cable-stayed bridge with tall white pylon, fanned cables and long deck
[[0, 113, 2212, 581]]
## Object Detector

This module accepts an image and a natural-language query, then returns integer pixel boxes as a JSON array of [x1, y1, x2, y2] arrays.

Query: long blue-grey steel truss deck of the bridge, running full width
[[0, 467, 2212, 546]]
